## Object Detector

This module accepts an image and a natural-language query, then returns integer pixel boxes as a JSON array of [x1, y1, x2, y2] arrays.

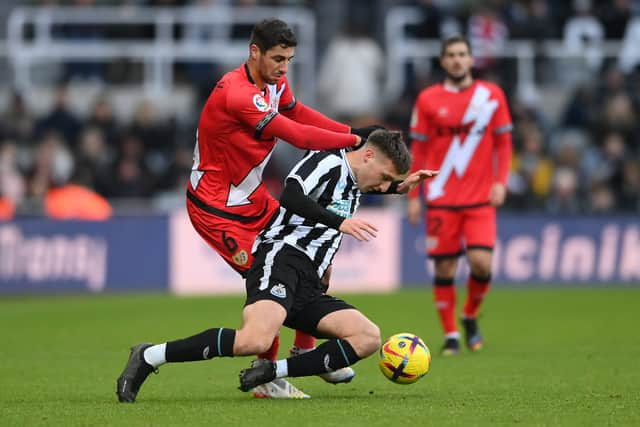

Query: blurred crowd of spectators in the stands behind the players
[[0, 0, 640, 218]]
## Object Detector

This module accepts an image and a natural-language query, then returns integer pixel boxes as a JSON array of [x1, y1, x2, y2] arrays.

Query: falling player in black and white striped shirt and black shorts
[[116, 130, 436, 401]]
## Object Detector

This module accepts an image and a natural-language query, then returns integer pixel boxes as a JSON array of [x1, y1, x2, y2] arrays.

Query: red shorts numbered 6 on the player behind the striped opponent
[[187, 199, 278, 275]]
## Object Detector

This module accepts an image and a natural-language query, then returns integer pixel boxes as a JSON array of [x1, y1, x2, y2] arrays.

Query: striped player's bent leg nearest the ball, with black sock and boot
[[240, 295, 380, 390]]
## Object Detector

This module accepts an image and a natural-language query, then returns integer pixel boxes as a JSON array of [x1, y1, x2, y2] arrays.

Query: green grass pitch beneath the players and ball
[[0, 288, 640, 427]]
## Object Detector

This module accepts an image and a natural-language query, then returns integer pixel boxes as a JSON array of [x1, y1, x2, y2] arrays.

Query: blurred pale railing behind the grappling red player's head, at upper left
[[7, 5, 316, 104]]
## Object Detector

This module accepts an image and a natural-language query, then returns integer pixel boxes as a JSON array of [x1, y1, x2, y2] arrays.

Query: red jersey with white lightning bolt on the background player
[[410, 80, 512, 207]]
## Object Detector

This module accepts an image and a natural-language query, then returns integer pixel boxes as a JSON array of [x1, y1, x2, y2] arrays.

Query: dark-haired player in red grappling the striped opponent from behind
[[187, 19, 375, 397]]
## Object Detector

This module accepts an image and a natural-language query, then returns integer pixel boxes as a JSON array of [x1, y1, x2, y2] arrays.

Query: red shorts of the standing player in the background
[[426, 205, 496, 257]]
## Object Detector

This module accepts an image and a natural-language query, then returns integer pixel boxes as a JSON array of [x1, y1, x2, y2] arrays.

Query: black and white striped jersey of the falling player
[[254, 150, 360, 277]]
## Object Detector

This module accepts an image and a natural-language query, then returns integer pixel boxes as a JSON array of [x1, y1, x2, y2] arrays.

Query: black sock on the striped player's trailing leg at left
[[166, 328, 236, 362]]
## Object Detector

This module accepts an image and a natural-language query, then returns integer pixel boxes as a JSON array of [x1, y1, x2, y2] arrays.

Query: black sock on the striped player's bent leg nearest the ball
[[287, 340, 360, 377]]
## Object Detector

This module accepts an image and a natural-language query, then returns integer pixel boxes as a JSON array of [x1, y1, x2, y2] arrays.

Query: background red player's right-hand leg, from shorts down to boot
[[462, 206, 496, 351]]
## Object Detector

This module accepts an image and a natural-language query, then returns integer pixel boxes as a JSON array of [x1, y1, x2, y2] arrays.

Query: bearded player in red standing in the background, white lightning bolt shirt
[[407, 36, 512, 355]]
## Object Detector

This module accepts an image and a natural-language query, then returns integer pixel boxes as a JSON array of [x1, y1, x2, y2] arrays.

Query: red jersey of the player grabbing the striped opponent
[[189, 65, 295, 222]]
